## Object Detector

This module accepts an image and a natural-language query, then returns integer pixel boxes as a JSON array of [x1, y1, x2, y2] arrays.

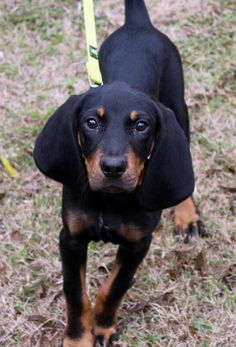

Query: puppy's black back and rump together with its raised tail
[[99, 0, 175, 99]]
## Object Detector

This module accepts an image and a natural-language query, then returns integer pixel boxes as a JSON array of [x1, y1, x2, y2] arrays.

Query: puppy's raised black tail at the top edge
[[125, 0, 151, 27]]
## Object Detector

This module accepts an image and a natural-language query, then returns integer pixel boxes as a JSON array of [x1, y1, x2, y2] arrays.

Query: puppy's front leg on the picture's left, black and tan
[[60, 228, 93, 347]]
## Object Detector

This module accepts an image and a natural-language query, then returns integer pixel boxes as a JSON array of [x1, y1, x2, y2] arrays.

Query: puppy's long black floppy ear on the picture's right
[[140, 103, 194, 210]]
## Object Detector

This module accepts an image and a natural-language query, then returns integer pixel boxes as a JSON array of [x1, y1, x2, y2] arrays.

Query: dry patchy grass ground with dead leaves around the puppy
[[0, 0, 236, 347]]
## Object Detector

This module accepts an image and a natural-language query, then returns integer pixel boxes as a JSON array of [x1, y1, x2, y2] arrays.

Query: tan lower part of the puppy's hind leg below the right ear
[[174, 197, 199, 231]]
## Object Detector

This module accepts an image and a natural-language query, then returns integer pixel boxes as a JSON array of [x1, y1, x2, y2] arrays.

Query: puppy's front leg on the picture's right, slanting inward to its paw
[[94, 235, 151, 347]]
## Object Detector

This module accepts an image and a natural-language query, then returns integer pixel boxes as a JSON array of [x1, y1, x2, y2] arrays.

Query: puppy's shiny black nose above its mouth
[[100, 157, 127, 178]]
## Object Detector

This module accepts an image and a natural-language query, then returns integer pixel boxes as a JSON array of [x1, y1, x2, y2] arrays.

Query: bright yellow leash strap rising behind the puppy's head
[[83, 0, 102, 88]]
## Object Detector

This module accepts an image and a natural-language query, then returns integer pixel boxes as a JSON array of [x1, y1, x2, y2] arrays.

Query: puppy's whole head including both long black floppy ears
[[34, 82, 193, 209]]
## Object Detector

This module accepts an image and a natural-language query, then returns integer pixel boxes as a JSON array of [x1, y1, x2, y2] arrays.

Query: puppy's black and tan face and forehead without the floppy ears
[[78, 83, 157, 193]]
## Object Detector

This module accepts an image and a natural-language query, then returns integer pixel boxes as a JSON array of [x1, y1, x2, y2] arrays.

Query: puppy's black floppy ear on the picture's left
[[34, 94, 87, 192]]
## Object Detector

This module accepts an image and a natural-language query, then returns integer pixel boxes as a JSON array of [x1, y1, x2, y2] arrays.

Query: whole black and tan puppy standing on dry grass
[[34, 0, 202, 347]]
